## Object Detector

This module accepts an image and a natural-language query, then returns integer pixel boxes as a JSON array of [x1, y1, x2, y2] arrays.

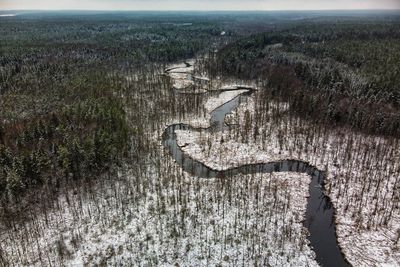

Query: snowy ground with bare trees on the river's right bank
[[177, 92, 400, 266]]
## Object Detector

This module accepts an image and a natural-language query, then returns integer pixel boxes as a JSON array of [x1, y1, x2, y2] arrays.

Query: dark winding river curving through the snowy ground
[[163, 64, 350, 267]]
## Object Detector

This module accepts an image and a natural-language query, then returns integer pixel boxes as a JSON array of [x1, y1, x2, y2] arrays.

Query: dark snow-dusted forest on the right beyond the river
[[214, 19, 400, 136]]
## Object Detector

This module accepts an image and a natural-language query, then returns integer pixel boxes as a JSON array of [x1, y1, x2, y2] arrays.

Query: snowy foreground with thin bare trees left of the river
[[0, 160, 317, 266]]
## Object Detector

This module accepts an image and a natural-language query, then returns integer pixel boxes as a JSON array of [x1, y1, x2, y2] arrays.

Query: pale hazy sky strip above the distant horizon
[[0, 0, 400, 10]]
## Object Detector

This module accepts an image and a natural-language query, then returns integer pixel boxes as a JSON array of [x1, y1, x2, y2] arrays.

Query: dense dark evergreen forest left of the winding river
[[0, 12, 219, 207]]
